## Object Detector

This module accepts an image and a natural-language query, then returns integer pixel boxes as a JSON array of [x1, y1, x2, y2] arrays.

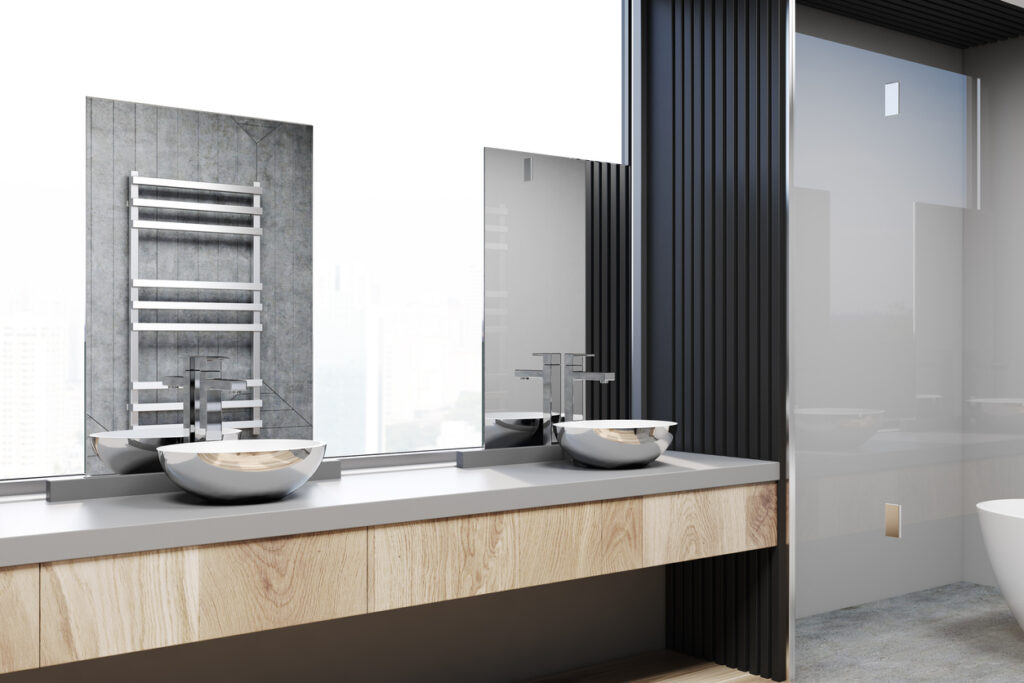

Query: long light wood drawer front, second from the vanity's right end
[[370, 498, 642, 611]]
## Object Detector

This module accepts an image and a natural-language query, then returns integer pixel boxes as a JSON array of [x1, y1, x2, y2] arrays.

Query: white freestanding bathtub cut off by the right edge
[[978, 498, 1024, 629]]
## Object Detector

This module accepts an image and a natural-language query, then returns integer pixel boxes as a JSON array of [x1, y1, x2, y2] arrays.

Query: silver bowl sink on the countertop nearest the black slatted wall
[[555, 420, 676, 469]]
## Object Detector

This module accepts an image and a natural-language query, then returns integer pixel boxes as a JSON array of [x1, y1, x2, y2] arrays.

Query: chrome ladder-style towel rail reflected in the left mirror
[[128, 171, 263, 435]]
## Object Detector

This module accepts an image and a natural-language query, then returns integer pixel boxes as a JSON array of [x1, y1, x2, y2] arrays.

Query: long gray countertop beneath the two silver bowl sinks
[[0, 452, 779, 566]]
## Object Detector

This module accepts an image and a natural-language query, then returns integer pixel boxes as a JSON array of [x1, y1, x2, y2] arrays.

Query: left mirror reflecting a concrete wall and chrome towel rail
[[85, 97, 313, 474]]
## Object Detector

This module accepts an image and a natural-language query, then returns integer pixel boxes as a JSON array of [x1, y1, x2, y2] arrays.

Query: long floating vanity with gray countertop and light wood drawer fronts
[[0, 452, 779, 672]]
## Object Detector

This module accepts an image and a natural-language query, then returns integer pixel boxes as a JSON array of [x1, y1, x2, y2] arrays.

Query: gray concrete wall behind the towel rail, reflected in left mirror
[[85, 97, 312, 474]]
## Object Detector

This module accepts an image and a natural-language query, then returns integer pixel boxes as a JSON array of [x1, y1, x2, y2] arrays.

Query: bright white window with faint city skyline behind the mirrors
[[0, 0, 621, 477]]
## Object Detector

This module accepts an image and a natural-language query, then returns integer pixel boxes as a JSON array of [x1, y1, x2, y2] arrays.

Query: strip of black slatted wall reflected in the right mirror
[[586, 162, 632, 420]]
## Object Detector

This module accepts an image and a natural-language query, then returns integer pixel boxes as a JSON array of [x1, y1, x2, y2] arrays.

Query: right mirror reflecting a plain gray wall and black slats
[[483, 148, 631, 447]]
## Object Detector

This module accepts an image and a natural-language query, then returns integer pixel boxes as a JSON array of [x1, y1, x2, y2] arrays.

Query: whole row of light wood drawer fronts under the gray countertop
[[18, 482, 777, 673]]
